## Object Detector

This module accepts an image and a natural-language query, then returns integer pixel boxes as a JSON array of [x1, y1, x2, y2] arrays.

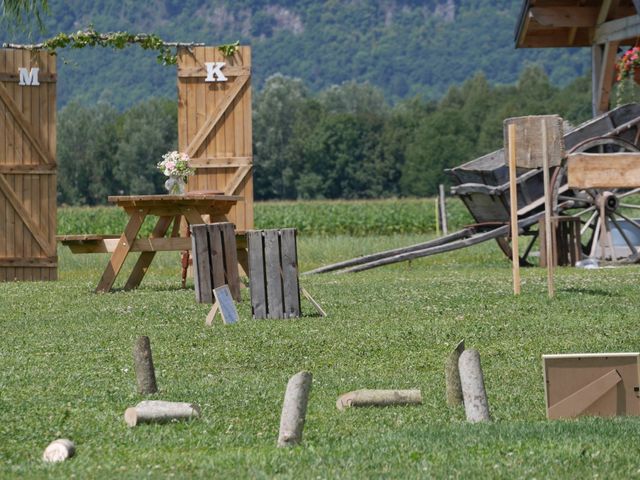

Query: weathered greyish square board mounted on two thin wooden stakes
[[504, 115, 564, 168]]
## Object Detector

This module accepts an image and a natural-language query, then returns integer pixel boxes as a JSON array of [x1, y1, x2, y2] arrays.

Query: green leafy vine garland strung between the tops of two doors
[[4, 26, 240, 65]]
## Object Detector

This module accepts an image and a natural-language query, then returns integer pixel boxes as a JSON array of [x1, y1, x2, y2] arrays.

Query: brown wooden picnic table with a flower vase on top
[[61, 193, 242, 292]]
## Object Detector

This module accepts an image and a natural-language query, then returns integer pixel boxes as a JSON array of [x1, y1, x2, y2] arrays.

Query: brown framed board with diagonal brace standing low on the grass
[[542, 352, 640, 419]]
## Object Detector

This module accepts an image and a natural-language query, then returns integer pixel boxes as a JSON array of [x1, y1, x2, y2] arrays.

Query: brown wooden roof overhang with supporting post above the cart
[[515, 0, 640, 115]]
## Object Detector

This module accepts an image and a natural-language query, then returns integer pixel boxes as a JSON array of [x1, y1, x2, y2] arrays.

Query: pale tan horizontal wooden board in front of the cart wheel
[[567, 152, 640, 188]]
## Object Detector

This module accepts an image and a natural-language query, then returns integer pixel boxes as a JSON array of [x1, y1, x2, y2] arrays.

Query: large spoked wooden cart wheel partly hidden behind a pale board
[[552, 137, 640, 263]]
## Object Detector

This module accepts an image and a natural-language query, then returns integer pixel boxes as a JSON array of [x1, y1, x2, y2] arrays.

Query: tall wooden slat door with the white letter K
[[178, 47, 253, 230]]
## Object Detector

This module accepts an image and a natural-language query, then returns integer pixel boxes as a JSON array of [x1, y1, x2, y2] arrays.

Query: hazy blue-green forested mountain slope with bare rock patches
[[0, 0, 589, 109]]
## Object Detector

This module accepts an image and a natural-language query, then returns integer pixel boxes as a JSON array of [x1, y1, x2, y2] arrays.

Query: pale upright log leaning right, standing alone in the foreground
[[278, 372, 312, 447]]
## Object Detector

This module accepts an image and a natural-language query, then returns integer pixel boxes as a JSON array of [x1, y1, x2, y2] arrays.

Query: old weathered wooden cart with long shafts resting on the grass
[[307, 104, 640, 273]]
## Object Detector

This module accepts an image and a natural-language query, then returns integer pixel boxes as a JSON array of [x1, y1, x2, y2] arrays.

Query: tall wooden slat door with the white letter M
[[0, 49, 57, 281]]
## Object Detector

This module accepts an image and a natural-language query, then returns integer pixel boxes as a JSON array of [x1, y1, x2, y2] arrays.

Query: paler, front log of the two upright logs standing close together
[[458, 349, 491, 423]]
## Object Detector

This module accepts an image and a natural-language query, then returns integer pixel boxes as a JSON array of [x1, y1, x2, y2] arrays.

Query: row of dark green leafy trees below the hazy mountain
[[58, 67, 591, 205]]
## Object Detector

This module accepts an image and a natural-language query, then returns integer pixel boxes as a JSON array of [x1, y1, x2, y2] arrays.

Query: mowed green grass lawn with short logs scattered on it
[[0, 199, 640, 478]]
